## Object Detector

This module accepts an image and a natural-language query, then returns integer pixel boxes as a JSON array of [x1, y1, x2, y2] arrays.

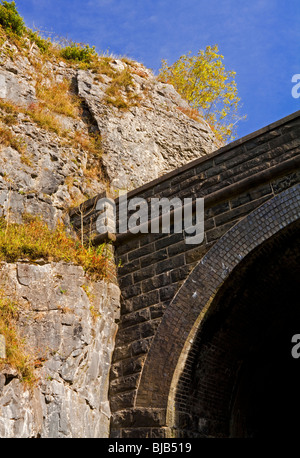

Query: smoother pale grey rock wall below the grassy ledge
[[0, 262, 119, 438]]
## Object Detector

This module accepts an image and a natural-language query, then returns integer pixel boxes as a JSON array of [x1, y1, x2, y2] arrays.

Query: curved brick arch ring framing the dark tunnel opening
[[135, 185, 300, 436]]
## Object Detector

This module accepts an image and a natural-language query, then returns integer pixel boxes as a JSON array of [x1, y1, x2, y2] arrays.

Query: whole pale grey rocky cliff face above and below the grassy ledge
[[0, 30, 216, 437]]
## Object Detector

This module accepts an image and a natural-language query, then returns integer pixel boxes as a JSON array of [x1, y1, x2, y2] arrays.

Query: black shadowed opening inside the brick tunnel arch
[[173, 222, 300, 437]]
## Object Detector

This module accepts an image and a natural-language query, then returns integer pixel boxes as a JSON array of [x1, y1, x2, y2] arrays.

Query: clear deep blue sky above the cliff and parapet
[[15, 0, 300, 138]]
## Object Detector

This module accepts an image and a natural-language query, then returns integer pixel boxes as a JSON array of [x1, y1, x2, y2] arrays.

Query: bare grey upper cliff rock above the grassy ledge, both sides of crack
[[0, 42, 216, 226]]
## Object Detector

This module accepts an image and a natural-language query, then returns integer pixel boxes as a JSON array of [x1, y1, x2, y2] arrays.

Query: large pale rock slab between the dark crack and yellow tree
[[77, 61, 216, 190]]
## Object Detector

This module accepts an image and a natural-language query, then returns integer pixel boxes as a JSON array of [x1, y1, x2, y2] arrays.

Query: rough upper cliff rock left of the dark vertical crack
[[0, 42, 106, 227]]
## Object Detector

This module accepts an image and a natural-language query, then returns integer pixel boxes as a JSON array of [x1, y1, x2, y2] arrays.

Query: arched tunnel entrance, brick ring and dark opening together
[[115, 185, 300, 438]]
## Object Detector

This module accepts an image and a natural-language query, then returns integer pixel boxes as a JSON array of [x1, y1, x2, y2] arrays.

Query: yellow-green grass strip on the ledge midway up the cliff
[[0, 218, 109, 280]]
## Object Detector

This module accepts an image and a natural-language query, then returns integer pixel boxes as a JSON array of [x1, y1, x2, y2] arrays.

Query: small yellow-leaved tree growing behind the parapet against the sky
[[159, 45, 245, 143]]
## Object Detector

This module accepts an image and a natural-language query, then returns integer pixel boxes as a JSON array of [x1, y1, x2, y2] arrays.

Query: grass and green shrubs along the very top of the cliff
[[0, 0, 144, 117]]
